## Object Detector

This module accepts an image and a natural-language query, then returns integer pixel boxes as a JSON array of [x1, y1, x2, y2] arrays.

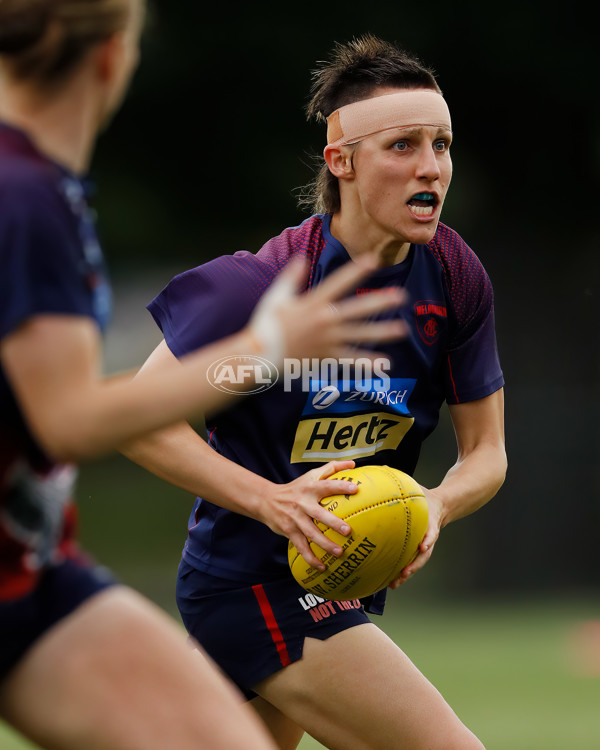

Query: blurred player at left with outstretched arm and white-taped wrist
[[0, 5, 403, 750]]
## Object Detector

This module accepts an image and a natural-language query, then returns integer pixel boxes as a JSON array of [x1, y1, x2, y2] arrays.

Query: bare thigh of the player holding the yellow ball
[[254, 624, 483, 750]]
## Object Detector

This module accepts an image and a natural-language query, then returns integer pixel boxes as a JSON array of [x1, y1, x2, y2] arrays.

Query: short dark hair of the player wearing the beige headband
[[300, 34, 441, 214]]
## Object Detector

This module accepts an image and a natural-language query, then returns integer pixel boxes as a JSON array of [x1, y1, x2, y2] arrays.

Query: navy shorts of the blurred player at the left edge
[[0, 560, 116, 679]]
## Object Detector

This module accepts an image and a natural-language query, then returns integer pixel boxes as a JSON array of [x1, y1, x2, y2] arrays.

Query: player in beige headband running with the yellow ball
[[128, 36, 506, 750]]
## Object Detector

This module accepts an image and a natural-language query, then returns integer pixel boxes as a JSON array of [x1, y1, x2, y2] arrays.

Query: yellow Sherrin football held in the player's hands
[[288, 466, 429, 601]]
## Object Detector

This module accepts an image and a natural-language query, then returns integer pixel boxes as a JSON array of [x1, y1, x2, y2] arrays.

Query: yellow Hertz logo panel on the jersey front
[[291, 412, 415, 463]]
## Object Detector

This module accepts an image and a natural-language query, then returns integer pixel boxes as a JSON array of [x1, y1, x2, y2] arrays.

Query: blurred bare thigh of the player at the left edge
[[0, 587, 274, 750]]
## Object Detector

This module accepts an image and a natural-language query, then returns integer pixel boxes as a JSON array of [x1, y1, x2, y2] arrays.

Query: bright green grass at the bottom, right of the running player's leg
[[0, 592, 600, 750]]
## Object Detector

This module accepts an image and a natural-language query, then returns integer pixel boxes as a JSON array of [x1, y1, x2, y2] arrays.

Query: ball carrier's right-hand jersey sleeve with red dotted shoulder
[[440, 227, 504, 404]]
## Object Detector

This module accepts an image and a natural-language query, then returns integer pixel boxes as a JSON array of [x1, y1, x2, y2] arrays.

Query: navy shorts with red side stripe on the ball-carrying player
[[177, 560, 370, 699]]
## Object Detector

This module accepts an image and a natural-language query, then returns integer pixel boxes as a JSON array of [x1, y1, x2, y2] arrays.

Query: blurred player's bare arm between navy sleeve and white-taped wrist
[[0, 315, 262, 461]]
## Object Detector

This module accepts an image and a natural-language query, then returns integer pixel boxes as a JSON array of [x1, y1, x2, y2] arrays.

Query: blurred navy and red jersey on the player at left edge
[[0, 124, 111, 600]]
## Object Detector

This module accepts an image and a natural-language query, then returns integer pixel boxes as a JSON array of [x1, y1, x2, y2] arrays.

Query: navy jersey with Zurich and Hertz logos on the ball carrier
[[148, 215, 503, 604]]
